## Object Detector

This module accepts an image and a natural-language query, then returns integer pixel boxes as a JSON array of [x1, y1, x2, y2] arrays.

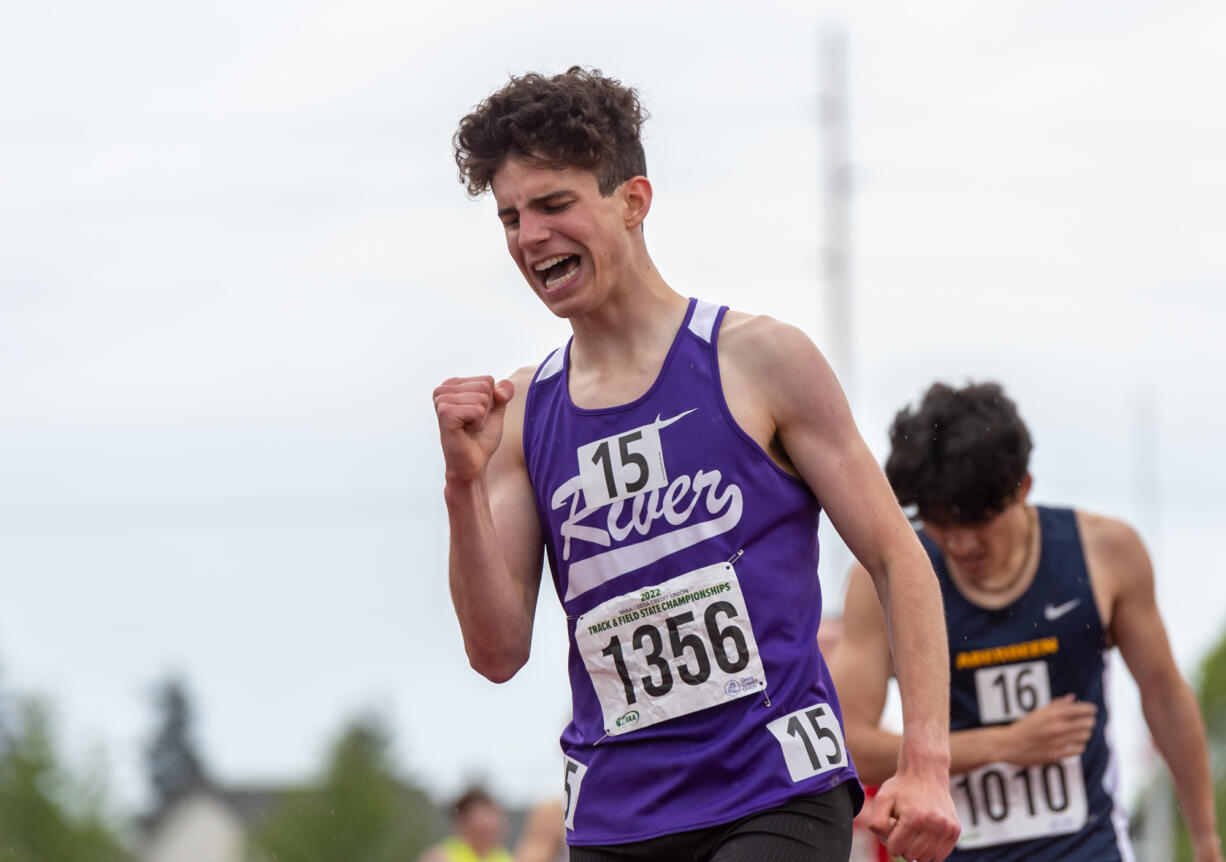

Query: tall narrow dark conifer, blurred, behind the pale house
[[145, 677, 208, 812]]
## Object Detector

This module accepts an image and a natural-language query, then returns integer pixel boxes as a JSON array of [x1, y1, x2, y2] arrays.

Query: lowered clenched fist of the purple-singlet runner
[[868, 770, 961, 862]]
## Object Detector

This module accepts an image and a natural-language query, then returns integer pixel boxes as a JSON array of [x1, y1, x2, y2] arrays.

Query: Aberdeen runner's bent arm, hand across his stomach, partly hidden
[[831, 565, 1097, 784]]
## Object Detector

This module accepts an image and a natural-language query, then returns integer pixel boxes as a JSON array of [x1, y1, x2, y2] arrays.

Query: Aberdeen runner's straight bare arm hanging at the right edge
[[1079, 513, 1222, 862]]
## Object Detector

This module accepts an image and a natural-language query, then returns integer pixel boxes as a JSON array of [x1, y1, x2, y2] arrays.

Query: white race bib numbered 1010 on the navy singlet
[[950, 757, 1086, 850]]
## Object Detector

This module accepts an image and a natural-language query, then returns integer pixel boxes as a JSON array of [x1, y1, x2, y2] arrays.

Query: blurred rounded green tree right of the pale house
[[253, 716, 435, 862]]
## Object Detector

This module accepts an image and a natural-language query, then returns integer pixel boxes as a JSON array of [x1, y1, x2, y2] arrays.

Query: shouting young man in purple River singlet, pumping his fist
[[434, 67, 956, 862]]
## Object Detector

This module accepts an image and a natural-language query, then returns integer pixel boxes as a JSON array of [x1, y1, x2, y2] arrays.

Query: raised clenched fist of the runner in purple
[[434, 375, 515, 482]]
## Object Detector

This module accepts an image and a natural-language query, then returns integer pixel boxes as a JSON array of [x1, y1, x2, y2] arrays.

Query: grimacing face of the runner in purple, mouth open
[[490, 158, 629, 316]]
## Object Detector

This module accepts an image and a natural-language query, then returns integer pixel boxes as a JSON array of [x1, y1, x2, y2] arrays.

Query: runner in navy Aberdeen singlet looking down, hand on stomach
[[832, 383, 1222, 862]]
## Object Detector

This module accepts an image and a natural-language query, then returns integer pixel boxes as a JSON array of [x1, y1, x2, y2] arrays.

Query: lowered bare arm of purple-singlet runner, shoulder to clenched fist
[[721, 318, 958, 860]]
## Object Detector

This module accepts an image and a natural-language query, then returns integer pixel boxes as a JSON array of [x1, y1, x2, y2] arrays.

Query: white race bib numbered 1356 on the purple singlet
[[575, 563, 766, 736]]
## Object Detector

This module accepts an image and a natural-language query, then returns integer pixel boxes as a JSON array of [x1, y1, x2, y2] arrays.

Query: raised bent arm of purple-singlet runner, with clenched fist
[[434, 369, 543, 682]]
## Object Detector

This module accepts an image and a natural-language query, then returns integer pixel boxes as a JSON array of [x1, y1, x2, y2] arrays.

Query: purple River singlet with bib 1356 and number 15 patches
[[524, 299, 858, 845]]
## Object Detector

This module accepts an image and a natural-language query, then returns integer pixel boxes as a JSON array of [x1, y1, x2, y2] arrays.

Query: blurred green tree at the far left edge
[[0, 698, 128, 862]]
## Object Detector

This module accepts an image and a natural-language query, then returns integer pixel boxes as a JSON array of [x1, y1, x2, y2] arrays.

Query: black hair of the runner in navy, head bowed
[[885, 383, 1032, 525]]
